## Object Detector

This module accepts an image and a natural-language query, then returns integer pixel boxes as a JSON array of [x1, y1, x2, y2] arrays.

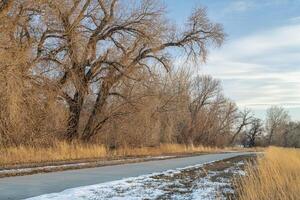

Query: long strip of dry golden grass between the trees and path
[[0, 142, 225, 166]]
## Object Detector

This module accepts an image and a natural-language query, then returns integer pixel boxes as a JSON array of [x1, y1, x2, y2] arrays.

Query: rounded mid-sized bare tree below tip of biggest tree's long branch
[[184, 75, 237, 145]]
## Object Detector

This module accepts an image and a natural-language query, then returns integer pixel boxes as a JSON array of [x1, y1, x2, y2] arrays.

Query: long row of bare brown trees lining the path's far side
[[0, 0, 298, 148]]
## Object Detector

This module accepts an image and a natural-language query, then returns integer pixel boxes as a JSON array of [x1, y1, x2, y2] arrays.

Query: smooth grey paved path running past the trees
[[0, 152, 255, 200]]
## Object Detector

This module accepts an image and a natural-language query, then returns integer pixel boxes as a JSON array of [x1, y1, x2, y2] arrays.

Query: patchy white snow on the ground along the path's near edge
[[28, 159, 246, 200]]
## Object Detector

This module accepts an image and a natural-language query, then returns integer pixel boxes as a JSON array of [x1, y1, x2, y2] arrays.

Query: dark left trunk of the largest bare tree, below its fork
[[65, 92, 84, 142]]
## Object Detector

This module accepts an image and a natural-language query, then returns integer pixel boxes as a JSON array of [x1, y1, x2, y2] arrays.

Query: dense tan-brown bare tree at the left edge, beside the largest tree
[[0, 0, 68, 145]]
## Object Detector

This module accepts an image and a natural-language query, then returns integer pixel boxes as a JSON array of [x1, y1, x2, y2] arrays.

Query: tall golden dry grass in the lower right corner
[[237, 147, 300, 200]]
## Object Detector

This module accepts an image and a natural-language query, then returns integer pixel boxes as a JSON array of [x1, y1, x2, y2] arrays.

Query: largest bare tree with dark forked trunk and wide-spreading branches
[[10, 0, 224, 141]]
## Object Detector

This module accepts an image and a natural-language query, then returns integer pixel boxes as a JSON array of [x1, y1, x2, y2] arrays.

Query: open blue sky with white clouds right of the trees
[[164, 0, 300, 120]]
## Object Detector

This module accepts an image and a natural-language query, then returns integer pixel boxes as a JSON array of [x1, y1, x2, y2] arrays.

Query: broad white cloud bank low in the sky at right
[[202, 24, 300, 112]]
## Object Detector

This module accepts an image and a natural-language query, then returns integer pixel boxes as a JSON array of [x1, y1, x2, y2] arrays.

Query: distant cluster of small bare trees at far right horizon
[[231, 106, 300, 148]]
